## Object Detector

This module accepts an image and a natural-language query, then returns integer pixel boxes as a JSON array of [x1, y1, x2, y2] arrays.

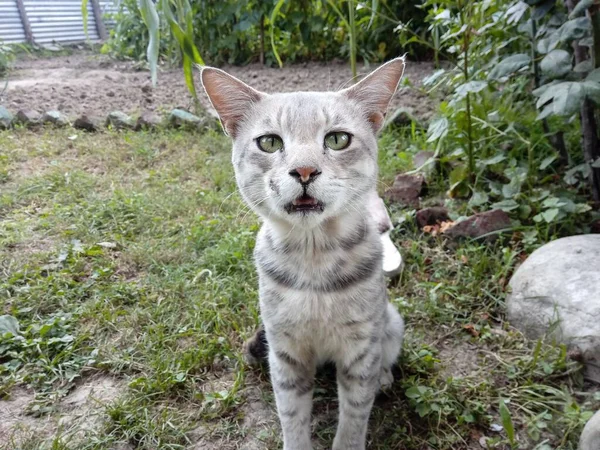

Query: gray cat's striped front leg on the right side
[[333, 340, 382, 450]]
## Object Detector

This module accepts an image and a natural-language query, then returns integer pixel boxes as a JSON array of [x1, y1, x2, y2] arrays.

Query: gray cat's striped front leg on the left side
[[269, 339, 316, 450]]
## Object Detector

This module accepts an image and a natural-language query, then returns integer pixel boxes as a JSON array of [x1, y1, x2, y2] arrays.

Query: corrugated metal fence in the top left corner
[[0, 0, 117, 44]]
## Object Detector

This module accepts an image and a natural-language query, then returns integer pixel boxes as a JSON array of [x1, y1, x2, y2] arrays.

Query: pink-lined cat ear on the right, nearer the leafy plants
[[342, 57, 404, 131]]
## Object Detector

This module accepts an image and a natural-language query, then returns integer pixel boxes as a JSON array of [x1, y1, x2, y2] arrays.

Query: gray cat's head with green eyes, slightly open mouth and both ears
[[202, 58, 404, 228]]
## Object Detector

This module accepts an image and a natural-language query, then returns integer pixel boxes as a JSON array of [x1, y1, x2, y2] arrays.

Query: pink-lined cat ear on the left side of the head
[[200, 67, 266, 138]]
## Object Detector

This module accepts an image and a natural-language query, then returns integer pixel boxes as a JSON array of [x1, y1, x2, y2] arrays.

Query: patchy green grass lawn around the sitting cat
[[0, 125, 600, 450]]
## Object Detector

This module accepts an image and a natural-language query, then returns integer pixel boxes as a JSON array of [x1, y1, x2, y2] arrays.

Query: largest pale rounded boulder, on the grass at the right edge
[[507, 234, 600, 382]]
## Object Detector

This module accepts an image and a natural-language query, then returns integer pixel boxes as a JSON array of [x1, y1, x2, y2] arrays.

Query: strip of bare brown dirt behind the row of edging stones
[[0, 51, 434, 119]]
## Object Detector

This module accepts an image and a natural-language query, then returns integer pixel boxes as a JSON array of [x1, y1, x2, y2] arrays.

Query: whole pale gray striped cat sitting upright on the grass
[[202, 58, 404, 450]]
